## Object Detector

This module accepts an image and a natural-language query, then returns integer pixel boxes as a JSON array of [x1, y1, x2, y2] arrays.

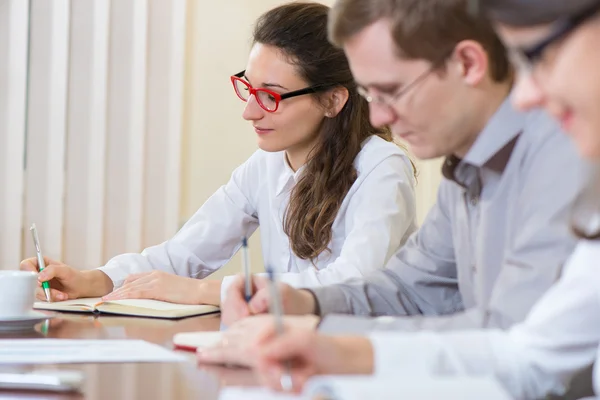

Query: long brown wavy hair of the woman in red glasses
[[253, 3, 410, 262]]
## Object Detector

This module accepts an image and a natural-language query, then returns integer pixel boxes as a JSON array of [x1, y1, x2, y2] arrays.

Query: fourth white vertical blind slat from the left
[[104, 0, 148, 259]]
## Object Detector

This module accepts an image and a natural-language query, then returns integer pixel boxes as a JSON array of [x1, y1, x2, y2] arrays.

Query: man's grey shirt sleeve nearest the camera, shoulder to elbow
[[482, 132, 592, 329]]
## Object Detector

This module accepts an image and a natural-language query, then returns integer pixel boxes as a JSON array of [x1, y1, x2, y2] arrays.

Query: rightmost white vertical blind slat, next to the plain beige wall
[[143, 0, 186, 243]]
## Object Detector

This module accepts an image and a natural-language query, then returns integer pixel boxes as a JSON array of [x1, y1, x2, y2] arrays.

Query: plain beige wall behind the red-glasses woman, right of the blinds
[[182, 0, 439, 275]]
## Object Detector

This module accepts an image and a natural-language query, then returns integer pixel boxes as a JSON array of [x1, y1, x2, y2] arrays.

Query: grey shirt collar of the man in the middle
[[442, 98, 526, 186]]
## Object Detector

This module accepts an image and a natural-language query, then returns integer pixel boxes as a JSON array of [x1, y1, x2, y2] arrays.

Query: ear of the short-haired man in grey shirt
[[453, 40, 489, 86]]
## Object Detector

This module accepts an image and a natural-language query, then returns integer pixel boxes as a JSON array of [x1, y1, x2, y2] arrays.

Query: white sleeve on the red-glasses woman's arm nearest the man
[[279, 154, 416, 287]]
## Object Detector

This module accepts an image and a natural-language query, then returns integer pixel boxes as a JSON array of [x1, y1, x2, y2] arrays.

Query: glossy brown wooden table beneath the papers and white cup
[[0, 313, 256, 400]]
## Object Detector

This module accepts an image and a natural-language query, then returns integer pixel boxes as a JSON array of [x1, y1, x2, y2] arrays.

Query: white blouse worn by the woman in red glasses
[[100, 136, 416, 298]]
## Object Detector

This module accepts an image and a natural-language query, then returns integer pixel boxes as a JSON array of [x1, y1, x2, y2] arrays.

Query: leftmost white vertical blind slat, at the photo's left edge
[[0, 0, 29, 269]]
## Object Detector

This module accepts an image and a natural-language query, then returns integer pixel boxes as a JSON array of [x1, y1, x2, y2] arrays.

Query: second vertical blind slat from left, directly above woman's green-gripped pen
[[23, 0, 70, 257]]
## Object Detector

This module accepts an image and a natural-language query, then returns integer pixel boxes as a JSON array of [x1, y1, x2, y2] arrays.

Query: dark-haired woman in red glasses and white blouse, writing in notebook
[[22, 3, 415, 304]]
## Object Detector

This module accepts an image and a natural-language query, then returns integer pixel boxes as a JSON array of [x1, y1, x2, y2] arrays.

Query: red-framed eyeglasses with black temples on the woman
[[231, 70, 336, 112]]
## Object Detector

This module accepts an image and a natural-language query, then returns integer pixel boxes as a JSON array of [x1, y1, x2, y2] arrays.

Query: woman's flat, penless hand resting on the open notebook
[[102, 271, 221, 305]]
